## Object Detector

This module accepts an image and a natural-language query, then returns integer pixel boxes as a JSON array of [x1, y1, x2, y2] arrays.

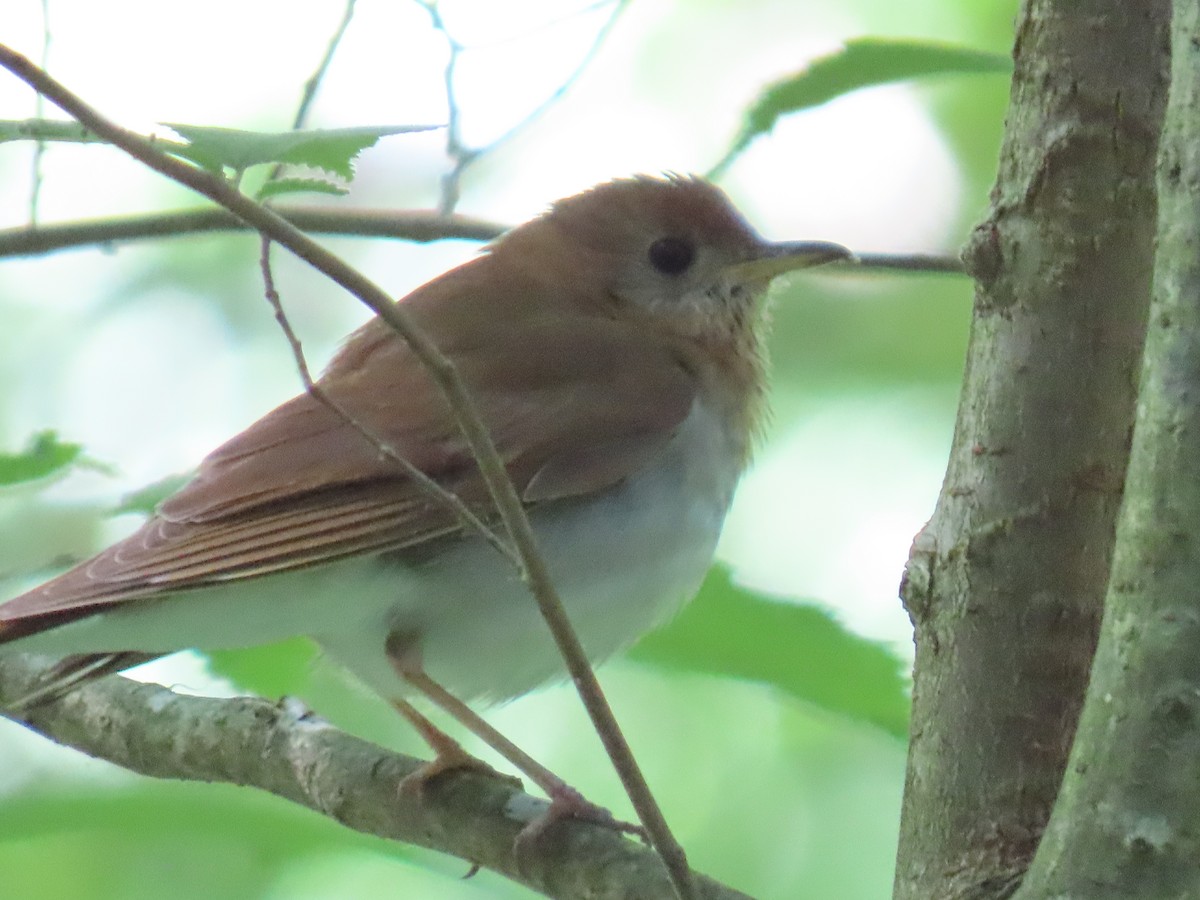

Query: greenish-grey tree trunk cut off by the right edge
[[1021, 0, 1200, 900]]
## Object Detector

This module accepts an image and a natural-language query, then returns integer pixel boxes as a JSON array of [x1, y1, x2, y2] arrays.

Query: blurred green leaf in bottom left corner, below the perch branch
[[0, 779, 412, 900]]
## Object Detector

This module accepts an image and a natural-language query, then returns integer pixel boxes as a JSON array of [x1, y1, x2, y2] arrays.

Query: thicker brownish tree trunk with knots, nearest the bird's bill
[[895, 0, 1170, 900]]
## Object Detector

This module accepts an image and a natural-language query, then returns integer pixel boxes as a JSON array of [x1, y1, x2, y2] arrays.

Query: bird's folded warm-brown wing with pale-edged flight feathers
[[0, 317, 696, 641]]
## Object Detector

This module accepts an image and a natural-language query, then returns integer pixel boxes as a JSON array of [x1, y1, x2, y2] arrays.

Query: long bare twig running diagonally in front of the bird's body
[[0, 44, 696, 900]]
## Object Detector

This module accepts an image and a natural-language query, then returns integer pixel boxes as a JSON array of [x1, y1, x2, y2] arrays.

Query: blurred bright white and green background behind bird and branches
[[0, 0, 1016, 900]]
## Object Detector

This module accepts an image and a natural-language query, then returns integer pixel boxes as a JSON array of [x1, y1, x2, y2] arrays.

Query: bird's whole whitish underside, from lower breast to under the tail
[[10, 402, 739, 701]]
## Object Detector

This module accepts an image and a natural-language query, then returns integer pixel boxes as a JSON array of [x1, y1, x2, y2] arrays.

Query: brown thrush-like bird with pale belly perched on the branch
[[0, 175, 852, 806]]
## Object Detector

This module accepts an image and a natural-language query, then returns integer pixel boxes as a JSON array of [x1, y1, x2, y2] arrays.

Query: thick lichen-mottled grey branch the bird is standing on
[[0, 656, 746, 900]]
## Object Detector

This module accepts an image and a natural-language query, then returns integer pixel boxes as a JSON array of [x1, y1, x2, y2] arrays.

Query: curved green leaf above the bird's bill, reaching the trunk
[[709, 37, 1013, 176]]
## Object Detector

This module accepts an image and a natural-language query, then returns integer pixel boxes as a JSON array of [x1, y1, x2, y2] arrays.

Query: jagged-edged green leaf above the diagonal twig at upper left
[[163, 122, 438, 181]]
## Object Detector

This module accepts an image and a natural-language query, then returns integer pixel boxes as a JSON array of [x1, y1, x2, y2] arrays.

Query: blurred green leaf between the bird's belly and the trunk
[[629, 566, 908, 739]]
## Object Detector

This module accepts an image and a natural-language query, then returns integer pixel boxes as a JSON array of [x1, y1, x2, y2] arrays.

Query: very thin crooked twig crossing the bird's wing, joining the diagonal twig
[[258, 235, 511, 570]]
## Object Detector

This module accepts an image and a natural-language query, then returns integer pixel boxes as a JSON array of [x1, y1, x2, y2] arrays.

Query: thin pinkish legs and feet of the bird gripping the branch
[[386, 635, 643, 842]]
